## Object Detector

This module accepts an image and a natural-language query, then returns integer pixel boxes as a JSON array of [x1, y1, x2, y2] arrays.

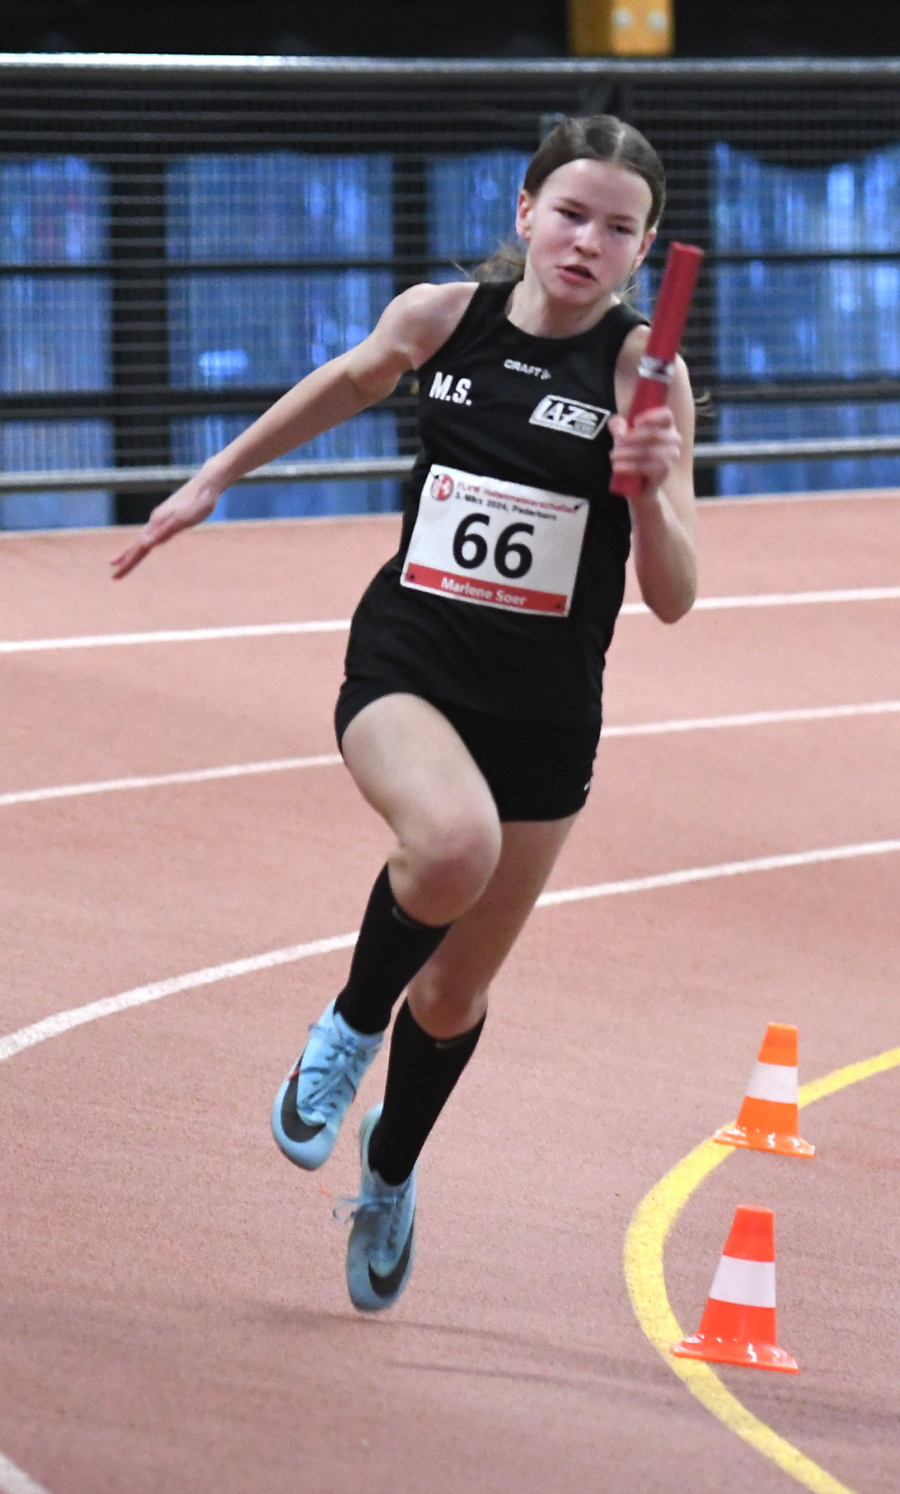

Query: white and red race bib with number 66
[[401, 466, 588, 617]]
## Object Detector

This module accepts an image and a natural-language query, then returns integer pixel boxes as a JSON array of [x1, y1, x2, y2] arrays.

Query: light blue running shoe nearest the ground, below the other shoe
[[335, 1106, 416, 1312]]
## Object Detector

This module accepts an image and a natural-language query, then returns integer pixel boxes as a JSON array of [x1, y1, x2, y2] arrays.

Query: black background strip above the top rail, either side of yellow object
[[0, 0, 900, 57]]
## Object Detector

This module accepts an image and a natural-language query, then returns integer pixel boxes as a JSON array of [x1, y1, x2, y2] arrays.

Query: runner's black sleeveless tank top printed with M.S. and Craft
[[347, 284, 644, 725]]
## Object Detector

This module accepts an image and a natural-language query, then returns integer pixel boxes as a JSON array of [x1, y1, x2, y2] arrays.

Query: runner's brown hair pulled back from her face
[[475, 114, 665, 281]]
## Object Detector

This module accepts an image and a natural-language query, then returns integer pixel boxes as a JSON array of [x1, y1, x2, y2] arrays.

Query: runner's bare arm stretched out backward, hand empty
[[111, 282, 475, 580]]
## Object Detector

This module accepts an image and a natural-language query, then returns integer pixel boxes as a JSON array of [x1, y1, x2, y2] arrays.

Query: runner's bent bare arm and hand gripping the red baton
[[610, 327, 697, 623]]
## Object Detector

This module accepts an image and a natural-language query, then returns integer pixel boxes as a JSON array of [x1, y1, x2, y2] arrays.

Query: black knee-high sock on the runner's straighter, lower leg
[[369, 1001, 484, 1186]]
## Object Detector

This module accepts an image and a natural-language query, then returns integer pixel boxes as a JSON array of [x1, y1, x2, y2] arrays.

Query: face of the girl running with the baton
[[516, 160, 655, 306]]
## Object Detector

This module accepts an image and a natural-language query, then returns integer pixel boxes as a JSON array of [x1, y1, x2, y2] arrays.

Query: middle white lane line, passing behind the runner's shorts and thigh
[[7, 701, 900, 808]]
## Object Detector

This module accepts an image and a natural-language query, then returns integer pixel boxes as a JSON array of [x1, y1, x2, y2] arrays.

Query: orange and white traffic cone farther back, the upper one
[[713, 1022, 815, 1156]]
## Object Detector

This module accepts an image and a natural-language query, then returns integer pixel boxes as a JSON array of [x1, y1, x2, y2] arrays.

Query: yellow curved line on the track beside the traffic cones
[[625, 1047, 900, 1494]]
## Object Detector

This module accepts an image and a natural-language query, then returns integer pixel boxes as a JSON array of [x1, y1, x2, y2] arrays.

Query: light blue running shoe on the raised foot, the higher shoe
[[272, 1001, 378, 1171]]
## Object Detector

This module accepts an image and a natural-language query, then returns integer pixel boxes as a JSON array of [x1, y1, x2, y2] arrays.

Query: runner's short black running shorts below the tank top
[[335, 675, 600, 820]]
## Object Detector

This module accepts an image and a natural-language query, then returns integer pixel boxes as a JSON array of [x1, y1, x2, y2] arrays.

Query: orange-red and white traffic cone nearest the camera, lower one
[[671, 1204, 797, 1374]]
